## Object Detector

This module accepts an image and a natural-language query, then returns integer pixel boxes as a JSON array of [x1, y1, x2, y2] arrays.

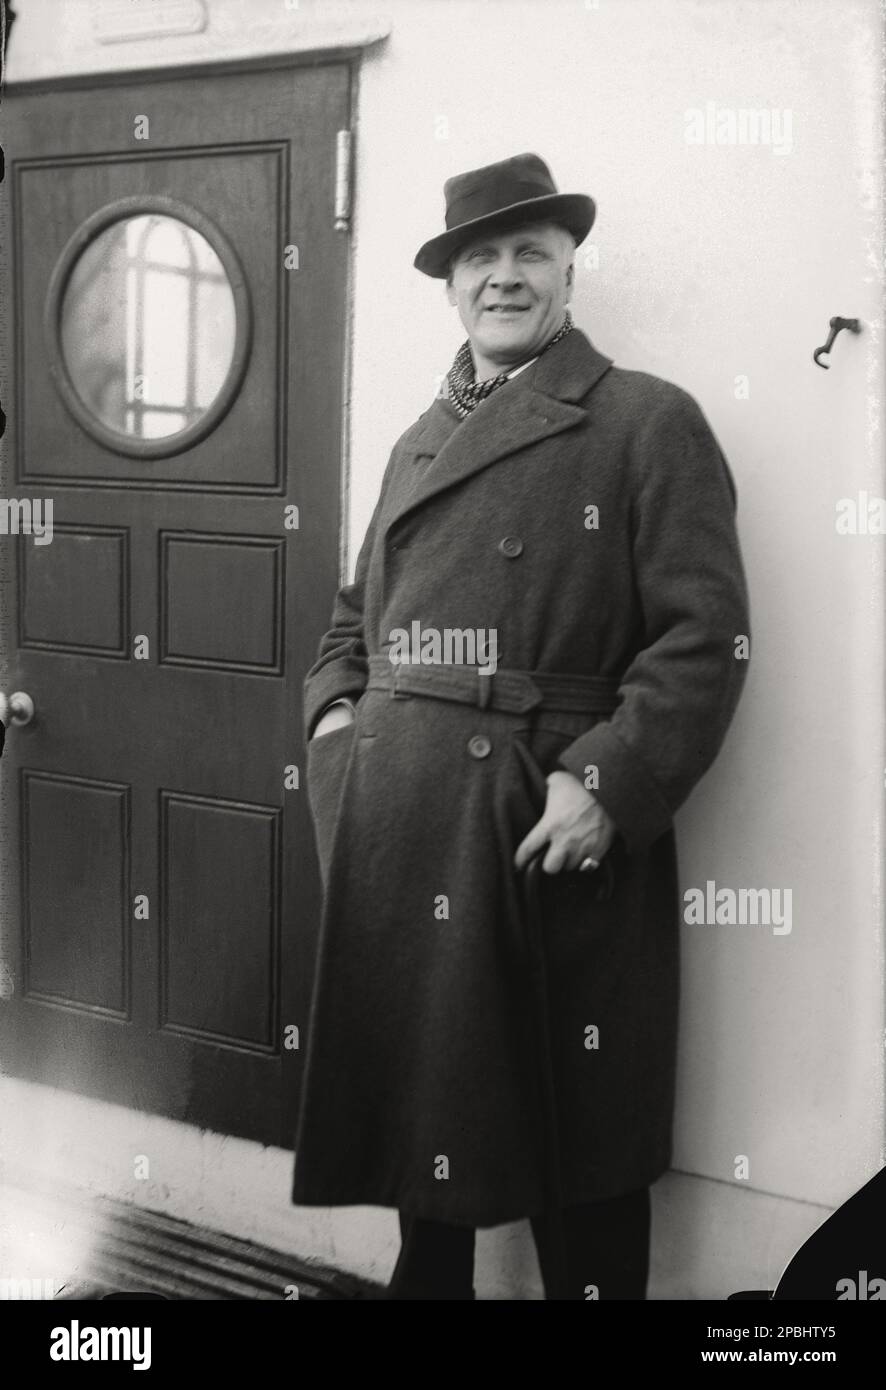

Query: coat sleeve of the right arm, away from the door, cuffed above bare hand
[[559, 385, 750, 851]]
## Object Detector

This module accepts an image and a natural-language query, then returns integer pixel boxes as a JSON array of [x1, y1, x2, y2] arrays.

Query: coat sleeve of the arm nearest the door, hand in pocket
[[305, 459, 394, 738]]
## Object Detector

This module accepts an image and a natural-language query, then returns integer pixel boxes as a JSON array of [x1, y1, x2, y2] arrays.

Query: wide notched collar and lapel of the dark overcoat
[[385, 328, 612, 530]]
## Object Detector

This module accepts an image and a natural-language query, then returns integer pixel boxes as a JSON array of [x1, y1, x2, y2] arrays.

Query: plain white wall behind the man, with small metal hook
[[7, 0, 886, 1297]]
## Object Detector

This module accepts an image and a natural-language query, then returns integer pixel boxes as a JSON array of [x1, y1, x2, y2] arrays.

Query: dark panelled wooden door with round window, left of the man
[[0, 63, 349, 1145]]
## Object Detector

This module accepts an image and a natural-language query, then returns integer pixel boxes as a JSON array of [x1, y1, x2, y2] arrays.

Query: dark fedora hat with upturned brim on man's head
[[413, 154, 597, 279]]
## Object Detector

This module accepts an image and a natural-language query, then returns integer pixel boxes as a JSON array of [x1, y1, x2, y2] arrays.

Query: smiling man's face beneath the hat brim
[[446, 222, 574, 367]]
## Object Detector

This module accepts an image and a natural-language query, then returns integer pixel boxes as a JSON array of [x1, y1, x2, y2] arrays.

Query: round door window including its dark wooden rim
[[47, 199, 249, 456]]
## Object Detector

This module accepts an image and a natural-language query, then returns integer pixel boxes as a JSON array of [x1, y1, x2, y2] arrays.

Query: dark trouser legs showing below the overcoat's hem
[[385, 1187, 651, 1301]]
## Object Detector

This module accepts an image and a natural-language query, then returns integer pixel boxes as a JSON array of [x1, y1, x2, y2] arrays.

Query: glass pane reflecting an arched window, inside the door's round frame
[[60, 213, 236, 439]]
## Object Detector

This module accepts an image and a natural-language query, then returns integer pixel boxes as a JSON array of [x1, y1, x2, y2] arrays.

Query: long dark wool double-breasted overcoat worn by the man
[[292, 329, 750, 1226]]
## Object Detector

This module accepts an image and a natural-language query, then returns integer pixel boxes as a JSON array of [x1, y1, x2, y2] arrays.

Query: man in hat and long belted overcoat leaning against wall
[[292, 154, 750, 1300]]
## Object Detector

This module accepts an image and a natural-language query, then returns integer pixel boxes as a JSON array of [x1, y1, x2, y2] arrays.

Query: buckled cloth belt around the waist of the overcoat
[[366, 656, 620, 714]]
